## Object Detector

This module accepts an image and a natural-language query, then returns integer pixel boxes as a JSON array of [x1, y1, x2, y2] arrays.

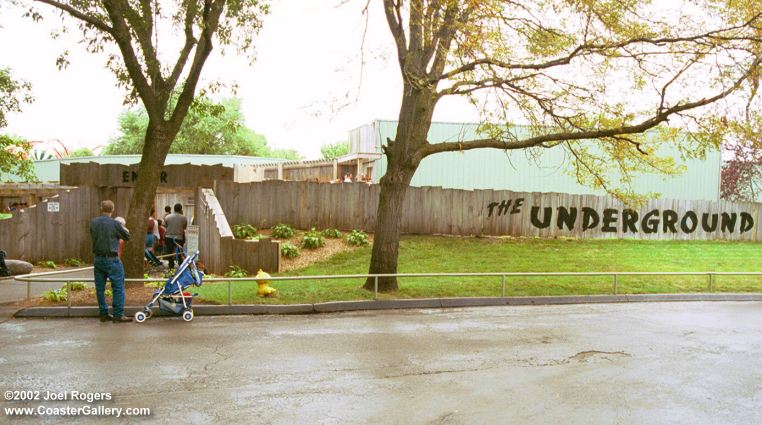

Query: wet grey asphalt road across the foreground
[[0, 302, 762, 424]]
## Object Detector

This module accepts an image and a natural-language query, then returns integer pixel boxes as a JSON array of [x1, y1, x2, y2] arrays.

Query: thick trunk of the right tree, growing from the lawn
[[363, 84, 436, 292]]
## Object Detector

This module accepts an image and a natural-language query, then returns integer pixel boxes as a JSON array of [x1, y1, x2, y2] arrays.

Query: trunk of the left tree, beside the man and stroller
[[122, 122, 175, 286]]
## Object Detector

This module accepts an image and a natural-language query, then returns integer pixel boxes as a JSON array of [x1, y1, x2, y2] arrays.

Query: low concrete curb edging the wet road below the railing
[[8, 293, 762, 318]]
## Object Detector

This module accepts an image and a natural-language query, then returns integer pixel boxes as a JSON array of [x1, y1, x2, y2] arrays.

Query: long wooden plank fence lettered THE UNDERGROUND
[[215, 181, 762, 241]]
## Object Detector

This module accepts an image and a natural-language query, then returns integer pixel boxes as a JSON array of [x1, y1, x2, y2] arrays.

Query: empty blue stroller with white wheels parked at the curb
[[135, 251, 204, 323]]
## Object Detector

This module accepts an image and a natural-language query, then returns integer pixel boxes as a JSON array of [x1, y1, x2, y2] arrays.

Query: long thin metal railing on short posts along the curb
[[15, 272, 762, 309]]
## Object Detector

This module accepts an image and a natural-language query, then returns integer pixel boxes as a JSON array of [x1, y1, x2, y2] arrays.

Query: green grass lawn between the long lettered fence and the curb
[[193, 236, 762, 304]]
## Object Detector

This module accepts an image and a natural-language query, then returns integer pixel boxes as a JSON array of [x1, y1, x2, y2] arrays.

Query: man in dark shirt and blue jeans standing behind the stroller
[[90, 201, 132, 323]]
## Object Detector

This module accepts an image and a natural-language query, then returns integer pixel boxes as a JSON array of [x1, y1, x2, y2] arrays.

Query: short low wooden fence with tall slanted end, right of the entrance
[[196, 188, 280, 274]]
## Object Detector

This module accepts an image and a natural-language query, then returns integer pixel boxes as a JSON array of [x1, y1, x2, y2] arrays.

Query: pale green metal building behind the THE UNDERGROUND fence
[[350, 120, 722, 201]]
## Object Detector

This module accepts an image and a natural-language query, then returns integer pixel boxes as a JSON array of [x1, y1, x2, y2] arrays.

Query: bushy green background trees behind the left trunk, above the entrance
[[103, 95, 300, 159]]
